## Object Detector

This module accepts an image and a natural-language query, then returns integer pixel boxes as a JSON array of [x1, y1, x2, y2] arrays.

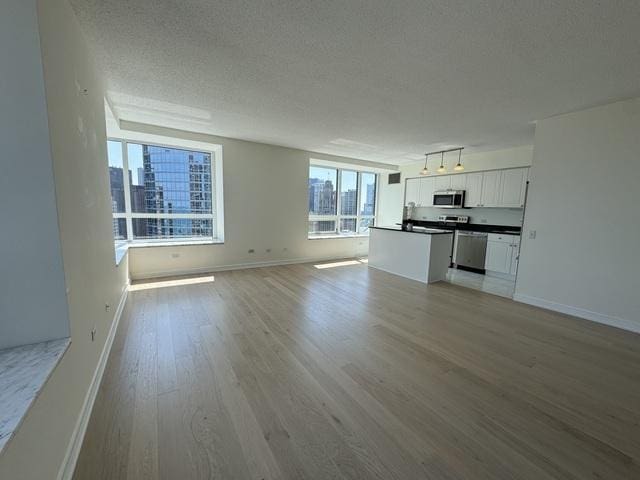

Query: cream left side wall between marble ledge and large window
[[0, 0, 127, 480]]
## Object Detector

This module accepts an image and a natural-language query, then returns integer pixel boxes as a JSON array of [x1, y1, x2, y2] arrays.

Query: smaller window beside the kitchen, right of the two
[[309, 165, 377, 238]]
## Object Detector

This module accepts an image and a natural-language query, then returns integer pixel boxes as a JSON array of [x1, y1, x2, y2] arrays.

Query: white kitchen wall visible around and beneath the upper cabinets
[[379, 145, 533, 225]]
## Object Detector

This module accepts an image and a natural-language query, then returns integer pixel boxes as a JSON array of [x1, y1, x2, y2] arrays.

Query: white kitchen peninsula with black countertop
[[369, 226, 453, 283]]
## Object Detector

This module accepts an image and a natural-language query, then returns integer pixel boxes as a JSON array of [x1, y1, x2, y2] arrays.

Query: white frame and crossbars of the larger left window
[[107, 137, 223, 246]]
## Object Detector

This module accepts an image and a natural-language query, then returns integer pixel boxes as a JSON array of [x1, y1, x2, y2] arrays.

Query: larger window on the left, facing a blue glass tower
[[107, 140, 217, 247]]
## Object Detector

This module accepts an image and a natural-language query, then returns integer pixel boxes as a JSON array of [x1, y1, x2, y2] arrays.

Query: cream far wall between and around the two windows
[[109, 122, 396, 279]]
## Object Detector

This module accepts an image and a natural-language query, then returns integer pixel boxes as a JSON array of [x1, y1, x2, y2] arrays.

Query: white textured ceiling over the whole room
[[71, 0, 640, 164]]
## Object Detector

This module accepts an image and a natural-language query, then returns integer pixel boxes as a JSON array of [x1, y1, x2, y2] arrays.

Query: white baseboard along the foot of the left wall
[[57, 283, 129, 480]]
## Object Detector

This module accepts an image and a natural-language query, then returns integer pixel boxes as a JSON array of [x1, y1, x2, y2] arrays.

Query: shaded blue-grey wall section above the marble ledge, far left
[[0, 0, 69, 349]]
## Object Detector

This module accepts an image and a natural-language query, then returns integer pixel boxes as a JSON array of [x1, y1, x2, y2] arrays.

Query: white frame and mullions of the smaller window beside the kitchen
[[307, 166, 380, 240]]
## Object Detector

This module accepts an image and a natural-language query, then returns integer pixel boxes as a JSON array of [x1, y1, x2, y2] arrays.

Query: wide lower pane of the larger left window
[[133, 218, 213, 240]]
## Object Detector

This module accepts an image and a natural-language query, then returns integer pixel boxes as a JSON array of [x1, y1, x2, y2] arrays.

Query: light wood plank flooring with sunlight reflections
[[72, 262, 640, 480]]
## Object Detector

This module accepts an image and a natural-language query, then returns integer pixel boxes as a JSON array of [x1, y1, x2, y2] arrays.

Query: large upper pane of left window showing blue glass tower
[[127, 143, 212, 214]]
